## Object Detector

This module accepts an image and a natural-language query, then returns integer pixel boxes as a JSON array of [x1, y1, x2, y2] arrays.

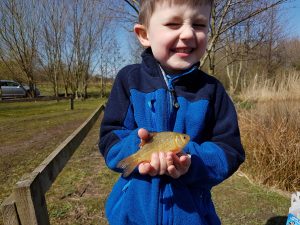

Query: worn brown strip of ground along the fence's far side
[[0, 120, 86, 207]]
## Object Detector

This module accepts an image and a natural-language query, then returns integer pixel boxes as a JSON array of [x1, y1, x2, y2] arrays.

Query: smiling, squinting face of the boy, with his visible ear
[[135, 1, 211, 73]]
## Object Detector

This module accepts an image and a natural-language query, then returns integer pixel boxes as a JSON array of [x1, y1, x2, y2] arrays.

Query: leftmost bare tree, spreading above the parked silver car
[[0, 0, 39, 96]]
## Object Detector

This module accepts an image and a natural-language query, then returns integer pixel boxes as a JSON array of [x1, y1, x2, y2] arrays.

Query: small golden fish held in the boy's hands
[[117, 131, 190, 177]]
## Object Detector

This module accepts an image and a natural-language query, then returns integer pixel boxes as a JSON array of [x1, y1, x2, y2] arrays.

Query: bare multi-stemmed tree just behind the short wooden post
[[68, 0, 109, 98]]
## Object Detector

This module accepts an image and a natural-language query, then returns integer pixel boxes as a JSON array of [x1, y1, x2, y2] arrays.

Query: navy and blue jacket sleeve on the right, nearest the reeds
[[181, 83, 245, 189]]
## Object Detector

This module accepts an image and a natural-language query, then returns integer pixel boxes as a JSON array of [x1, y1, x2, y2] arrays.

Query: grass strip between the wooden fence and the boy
[[46, 114, 118, 225]]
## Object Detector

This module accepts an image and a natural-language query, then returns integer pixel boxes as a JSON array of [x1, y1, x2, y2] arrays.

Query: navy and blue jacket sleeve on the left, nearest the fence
[[99, 67, 140, 172]]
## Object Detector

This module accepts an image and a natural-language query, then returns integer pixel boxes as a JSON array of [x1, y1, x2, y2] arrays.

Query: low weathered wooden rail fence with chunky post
[[1, 105, 104, 225]]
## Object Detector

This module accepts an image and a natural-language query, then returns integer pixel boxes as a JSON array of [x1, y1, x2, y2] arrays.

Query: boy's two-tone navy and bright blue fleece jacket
[[99, 49, 245, 225]]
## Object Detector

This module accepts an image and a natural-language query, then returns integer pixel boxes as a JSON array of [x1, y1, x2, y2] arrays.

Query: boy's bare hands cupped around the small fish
[[138, 128, 191, 178]]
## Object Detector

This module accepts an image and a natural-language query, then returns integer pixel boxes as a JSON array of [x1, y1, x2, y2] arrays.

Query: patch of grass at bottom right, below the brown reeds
[[212, 172, 290, 225]]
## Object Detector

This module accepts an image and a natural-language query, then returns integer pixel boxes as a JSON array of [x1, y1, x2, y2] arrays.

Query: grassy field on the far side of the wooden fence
[[0, 99, 103, 208]]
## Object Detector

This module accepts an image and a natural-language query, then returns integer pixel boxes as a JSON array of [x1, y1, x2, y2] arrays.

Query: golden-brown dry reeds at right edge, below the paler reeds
[[239, 101, 300, 191]]
